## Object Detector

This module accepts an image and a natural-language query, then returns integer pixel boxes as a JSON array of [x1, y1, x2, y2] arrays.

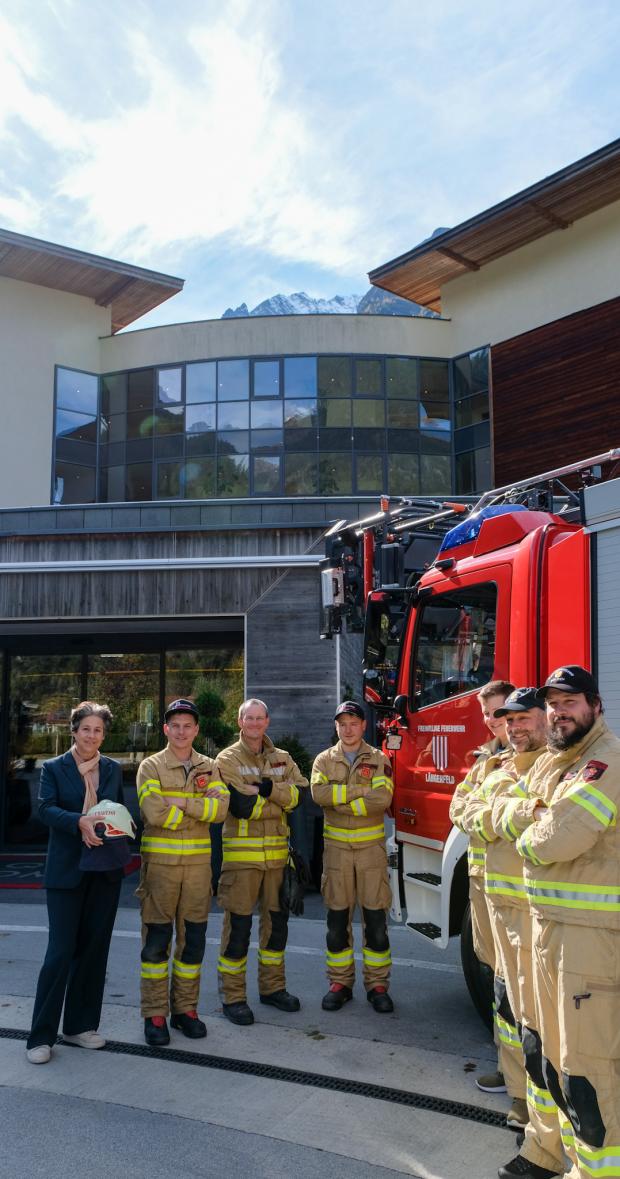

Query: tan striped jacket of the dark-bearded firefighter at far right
[[516, 717, 620, 929]]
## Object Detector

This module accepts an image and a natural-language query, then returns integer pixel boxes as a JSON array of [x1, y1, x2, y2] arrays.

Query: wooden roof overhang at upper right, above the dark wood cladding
[[368, 139, 620, 312]]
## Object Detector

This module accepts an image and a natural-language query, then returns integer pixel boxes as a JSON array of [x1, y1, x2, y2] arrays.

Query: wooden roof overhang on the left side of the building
[[0, 229, 184, 332]]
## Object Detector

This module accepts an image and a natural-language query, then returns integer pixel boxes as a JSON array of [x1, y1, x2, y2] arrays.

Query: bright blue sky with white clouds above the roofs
[[0, 0, 620, 328]]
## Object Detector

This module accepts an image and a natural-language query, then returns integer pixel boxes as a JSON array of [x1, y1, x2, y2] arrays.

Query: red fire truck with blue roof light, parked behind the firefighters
[[322, 450, 620, 1017]]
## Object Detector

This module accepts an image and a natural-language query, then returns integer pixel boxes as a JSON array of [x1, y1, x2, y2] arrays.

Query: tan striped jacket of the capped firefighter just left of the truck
[[310, 742, 394, 848]]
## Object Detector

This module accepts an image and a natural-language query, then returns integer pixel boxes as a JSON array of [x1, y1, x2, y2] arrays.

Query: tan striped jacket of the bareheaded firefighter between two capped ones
[[217, 736, 308, 869]]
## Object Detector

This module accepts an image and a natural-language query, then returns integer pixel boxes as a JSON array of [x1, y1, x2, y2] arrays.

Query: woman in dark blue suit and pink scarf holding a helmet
[[26, 700, 123, 1065]]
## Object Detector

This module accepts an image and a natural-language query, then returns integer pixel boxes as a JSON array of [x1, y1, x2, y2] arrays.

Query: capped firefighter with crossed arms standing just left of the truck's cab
[[311, 700, 394, 1014]]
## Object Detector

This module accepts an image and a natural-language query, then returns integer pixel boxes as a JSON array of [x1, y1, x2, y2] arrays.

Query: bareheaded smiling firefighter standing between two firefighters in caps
[[218, 699, 308, 1025]]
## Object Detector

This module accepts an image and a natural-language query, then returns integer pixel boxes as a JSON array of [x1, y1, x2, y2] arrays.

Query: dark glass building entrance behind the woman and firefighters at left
[[0, 619, 244, 851]]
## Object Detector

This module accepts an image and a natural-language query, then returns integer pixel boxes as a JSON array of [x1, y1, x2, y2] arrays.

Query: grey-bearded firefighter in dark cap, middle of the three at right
[[466, 687, 563, 1179]]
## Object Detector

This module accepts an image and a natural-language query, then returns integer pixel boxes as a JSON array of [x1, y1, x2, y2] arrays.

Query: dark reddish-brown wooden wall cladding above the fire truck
[[492, 298, 620, 487]]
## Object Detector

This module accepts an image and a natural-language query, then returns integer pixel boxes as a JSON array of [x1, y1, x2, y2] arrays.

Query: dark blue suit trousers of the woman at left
[[27, 872, 121, 1048]]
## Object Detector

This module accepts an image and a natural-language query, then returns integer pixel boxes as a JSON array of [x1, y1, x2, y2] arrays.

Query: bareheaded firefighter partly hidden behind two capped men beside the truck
[[450, 679, 526, 1103]]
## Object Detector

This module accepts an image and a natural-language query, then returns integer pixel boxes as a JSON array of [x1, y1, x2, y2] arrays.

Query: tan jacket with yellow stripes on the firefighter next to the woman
[[137, 745, 229, 865]]
